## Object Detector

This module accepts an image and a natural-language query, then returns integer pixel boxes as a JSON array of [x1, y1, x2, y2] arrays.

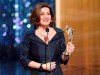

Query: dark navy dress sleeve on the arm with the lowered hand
[[19, 35, 31, 67]]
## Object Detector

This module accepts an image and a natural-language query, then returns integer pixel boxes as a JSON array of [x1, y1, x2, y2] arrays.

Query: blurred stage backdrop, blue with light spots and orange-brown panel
[[0, 0, 100, 75]]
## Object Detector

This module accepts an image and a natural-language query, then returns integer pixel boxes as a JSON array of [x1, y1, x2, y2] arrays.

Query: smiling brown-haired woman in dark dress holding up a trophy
[[20, 3, 74, 75]]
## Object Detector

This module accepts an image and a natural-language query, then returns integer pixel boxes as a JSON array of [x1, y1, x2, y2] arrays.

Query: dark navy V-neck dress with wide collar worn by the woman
[[20, 27, 69, 75]]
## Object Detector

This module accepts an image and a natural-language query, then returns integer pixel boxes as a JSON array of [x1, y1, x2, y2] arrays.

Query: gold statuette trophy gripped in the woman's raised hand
[[63, 25, 74, 56]]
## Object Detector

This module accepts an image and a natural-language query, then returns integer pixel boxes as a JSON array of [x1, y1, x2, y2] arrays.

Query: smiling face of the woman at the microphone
[[40, 7, 51, 26]]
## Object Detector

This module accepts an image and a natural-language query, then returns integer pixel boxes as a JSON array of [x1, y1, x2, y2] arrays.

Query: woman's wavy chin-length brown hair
[[29, 3, 55, 29]]
